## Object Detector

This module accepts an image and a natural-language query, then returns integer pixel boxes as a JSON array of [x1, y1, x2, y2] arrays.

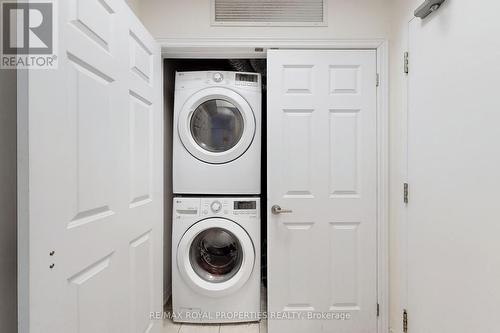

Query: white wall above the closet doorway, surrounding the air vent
[[139, 0, 393, 38]]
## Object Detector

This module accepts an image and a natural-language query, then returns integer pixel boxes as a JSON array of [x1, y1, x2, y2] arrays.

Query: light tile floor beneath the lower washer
[[162, 288, 267, 333]]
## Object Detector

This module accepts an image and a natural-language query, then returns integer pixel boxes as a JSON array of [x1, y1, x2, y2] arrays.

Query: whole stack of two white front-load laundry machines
[[172, 71, 262, 323]]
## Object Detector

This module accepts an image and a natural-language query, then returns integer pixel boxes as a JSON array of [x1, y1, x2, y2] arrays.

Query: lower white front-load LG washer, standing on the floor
[[172, 197, 261, 323]]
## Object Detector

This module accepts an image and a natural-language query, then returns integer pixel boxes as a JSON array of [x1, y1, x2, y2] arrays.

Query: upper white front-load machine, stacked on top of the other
[[173, 71, 262, 195]]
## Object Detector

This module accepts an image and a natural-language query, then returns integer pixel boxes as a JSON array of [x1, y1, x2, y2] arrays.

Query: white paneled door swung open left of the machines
[[19, 0, 163, 333]]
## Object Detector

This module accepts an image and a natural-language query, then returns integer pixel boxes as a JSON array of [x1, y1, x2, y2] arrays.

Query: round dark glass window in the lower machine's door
[[189, 228, 243, 283]]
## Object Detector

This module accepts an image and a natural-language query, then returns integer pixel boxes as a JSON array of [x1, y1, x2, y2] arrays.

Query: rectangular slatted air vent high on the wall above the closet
[[211, 0, 327, 26]]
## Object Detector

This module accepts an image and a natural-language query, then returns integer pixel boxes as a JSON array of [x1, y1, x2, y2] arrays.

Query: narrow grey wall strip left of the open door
[[0, 69, 17, 332]]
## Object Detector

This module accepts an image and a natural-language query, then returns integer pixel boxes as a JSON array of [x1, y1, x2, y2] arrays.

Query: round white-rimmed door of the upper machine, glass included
[[178, 87, 255, 164]]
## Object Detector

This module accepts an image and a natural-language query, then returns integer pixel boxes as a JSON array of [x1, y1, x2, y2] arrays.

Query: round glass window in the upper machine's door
[[190, 99, 244, 153]]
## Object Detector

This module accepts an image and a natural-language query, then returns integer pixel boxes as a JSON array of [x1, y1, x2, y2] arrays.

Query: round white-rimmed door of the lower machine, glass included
[[177, 218, 255, 297]]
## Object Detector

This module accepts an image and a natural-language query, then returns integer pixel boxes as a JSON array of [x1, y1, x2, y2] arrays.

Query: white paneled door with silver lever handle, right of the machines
[[267, 50, 377, 333]]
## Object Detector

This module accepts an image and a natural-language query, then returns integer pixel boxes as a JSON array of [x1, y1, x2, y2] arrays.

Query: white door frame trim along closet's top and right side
[[157, 37, 389, 333]]
